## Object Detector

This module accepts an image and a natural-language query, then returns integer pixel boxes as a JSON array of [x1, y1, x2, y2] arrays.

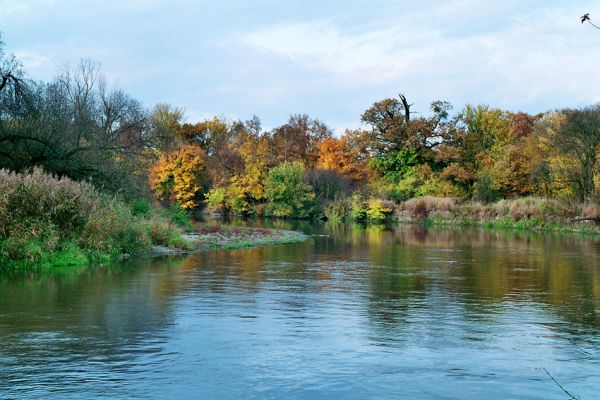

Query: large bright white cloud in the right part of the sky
[[241, 1, 600, 109]]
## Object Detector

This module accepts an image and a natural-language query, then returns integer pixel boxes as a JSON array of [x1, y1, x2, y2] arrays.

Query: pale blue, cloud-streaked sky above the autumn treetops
[[0, 0, 600, 133]]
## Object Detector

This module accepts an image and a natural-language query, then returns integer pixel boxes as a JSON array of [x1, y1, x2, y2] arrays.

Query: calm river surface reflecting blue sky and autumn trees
[[0, 221, 600, 399]]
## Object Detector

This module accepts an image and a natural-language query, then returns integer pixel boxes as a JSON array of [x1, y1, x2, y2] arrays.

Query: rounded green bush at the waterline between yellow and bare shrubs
[[265, 161, 315, 218]]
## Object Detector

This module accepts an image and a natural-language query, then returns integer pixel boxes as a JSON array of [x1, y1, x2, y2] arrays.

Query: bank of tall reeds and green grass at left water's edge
[[0, 169, 188, 269]]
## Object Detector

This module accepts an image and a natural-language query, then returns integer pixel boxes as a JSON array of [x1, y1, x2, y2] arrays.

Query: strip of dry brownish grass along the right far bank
[[393, 197, 600, 234]]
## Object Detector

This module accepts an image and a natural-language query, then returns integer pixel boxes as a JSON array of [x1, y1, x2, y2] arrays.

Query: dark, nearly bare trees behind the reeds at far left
[[0, 60, 150, 194]]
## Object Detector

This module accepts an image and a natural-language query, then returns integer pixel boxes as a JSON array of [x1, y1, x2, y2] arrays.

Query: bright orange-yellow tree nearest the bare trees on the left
[[150, 145, 206, 210]]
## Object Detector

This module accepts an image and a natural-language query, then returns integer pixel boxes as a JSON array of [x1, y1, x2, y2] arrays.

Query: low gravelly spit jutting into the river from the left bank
[[150, 225, 308, 256]]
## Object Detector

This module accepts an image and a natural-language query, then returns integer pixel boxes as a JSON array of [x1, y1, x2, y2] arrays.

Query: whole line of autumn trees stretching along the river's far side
[[0, 35, 600, 219]]
